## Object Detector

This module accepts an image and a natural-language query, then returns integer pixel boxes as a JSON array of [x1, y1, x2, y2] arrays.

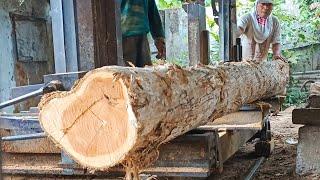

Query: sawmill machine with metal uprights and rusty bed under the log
[[0, 0, 279, 178]]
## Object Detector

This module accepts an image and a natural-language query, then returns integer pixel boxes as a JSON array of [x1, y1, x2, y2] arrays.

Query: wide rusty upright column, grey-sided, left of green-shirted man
[[76, 0, 124, 71]]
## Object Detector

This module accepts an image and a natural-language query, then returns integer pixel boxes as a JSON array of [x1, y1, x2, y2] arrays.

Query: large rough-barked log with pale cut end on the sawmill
[[39, 61, 289, 169]]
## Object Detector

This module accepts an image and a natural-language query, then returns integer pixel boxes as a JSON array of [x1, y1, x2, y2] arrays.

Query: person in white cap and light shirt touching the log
[[237, 0, 285, 61]]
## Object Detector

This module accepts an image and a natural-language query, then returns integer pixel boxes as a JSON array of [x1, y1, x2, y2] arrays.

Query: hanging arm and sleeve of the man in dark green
[[147, 0, 166, 59]]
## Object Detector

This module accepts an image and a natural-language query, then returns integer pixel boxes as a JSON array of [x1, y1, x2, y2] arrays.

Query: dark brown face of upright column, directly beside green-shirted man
[[93, 0, 124, 68]]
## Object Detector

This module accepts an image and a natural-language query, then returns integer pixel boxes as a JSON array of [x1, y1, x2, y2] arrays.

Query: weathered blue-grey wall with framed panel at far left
[[0, 0, 54, 111]]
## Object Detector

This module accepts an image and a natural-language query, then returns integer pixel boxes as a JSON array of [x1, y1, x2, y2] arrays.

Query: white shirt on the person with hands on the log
[[237, 14, 280, 61]]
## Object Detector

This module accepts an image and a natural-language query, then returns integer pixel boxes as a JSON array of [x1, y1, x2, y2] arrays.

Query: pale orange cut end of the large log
[[40, 71, 137, 169]]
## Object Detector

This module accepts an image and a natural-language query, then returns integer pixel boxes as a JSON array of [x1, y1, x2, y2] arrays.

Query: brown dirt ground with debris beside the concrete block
[[209, 107, 320, 180]]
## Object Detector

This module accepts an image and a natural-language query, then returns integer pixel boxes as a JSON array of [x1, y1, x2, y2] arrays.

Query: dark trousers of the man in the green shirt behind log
[[122, 34, 152, 67]]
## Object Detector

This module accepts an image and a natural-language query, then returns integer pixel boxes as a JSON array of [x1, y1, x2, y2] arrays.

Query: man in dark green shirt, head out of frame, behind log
[[121, 0, 165, 67]]
